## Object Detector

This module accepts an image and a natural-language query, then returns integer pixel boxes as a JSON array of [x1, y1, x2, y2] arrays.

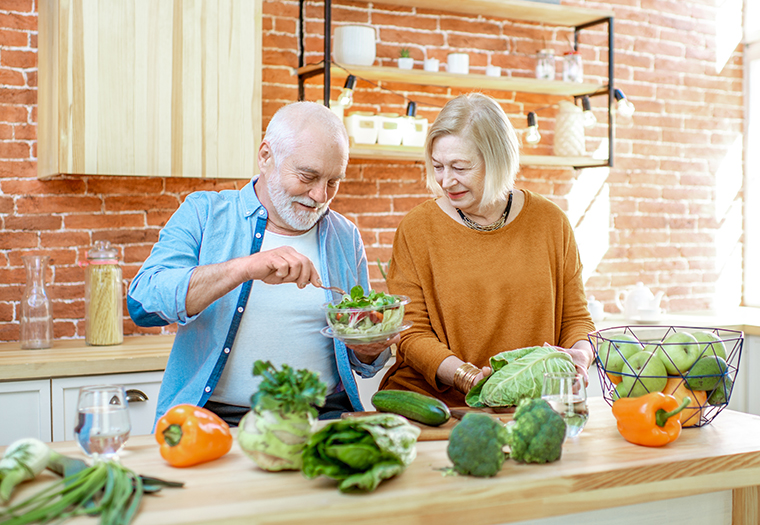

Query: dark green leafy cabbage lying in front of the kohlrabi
[[303, 414, 420, 492]]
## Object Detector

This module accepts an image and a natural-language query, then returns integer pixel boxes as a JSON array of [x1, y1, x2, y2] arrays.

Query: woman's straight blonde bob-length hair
[[425, 93, 520, 207]]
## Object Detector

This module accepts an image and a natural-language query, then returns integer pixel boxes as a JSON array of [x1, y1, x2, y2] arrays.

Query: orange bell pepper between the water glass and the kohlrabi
[[155, 405, 232, 467]]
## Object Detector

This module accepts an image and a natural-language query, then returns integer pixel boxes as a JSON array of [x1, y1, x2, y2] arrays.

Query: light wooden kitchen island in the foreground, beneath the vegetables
[[2, 398, 760, 525]]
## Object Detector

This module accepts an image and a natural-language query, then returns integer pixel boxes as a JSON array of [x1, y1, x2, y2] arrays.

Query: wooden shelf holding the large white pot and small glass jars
[[295, 63, 607, 97]]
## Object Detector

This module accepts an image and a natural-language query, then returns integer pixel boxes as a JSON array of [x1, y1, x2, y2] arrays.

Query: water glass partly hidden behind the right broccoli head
[[541, 372, 588, 438]]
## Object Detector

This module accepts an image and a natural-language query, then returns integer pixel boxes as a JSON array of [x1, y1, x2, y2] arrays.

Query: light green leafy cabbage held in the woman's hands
[[465, 346, 575, 408]]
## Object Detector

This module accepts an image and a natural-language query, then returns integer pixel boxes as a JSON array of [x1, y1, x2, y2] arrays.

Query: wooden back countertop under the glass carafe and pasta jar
[[0, 335, 174, 381]]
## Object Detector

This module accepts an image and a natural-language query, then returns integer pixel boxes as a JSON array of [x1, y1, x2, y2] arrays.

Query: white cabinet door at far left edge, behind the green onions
[[0, 379, 51, 446]]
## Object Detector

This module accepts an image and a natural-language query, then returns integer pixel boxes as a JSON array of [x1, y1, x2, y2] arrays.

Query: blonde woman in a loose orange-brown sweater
[[380, 93, 594, 406]]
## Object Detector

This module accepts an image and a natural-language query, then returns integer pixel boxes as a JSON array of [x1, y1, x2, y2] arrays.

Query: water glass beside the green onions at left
[[74, 385, 131, 461]]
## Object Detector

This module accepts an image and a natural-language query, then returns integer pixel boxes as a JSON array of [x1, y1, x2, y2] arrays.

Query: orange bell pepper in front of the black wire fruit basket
[[612, 392, 691, 447]]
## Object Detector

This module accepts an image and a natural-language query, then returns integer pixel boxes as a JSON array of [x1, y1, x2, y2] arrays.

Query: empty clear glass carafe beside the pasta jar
[[21, 255, 53, 349]]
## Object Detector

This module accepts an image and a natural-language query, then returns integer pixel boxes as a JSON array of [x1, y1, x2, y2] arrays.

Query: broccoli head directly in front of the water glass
[[504, 398, 566, 463]]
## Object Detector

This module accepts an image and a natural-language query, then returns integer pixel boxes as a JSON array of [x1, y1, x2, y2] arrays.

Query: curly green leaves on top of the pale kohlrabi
[[251, 360, 327, 417]]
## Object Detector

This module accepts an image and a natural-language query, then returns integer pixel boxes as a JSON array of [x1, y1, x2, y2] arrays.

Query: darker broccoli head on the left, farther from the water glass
[[446, 413, 507, 477]]
